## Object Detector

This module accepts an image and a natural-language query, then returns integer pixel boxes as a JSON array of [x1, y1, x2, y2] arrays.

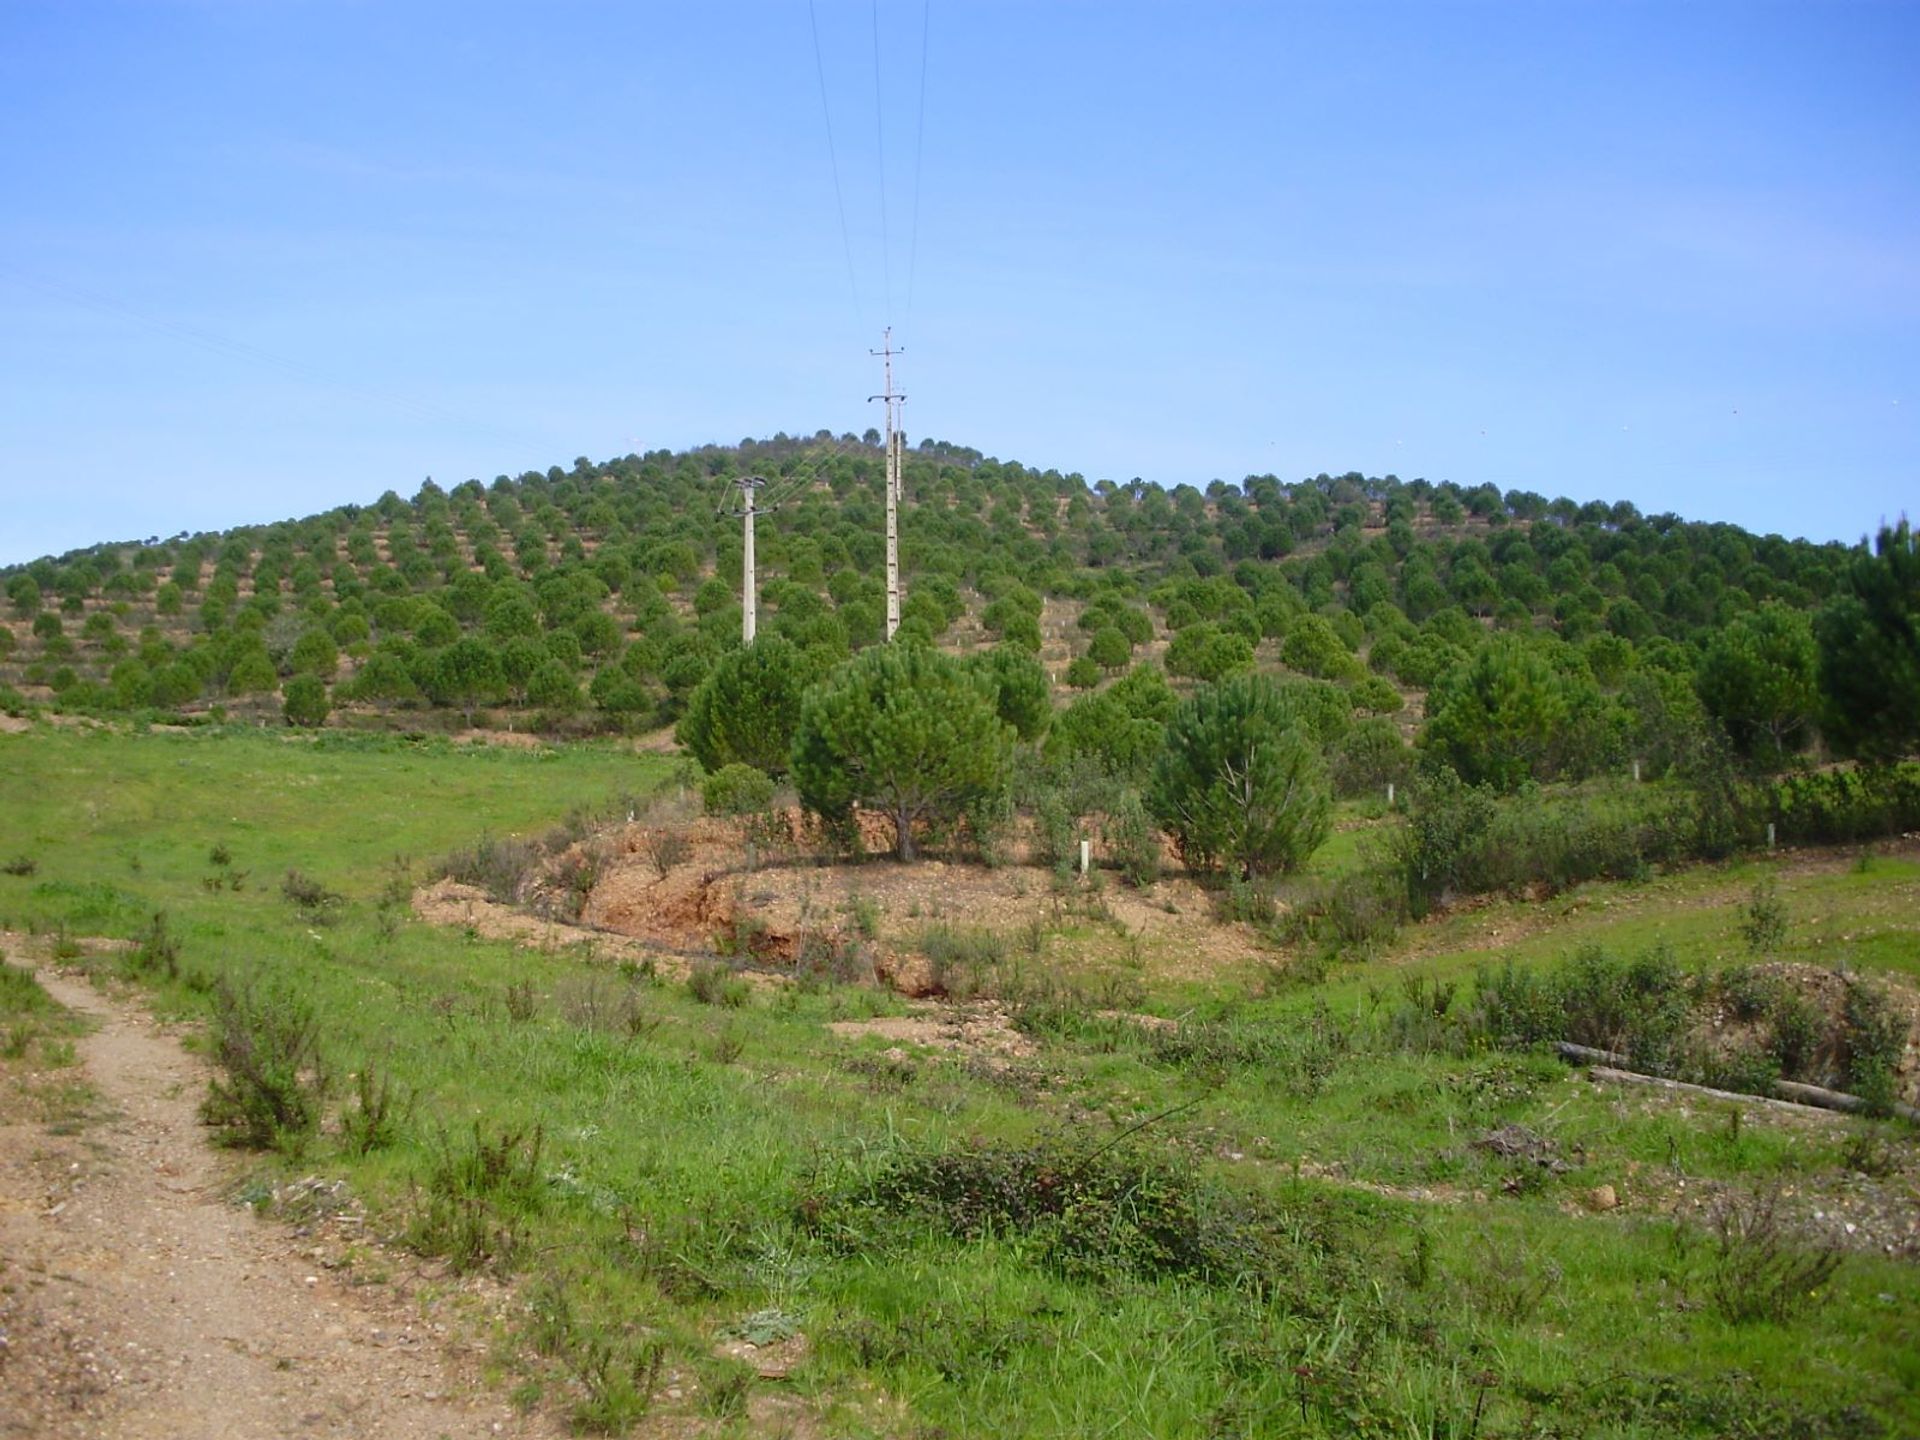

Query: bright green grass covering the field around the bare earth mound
[[0, 730, 1920, 1440]]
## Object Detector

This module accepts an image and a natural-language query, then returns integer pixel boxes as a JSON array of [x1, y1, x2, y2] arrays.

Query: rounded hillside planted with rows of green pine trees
[[0, 432, 1857, 768]]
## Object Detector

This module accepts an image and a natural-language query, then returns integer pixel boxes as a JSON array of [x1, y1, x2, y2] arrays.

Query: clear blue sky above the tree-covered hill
[[0, 0, 1920, 563]]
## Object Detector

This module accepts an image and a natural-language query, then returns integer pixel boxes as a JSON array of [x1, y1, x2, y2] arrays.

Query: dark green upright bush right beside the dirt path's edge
[[200, 981, 326, 1154]]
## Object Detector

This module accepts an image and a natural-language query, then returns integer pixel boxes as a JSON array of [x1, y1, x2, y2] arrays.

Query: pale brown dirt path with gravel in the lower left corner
[[0, 970, 549, 1440]]
